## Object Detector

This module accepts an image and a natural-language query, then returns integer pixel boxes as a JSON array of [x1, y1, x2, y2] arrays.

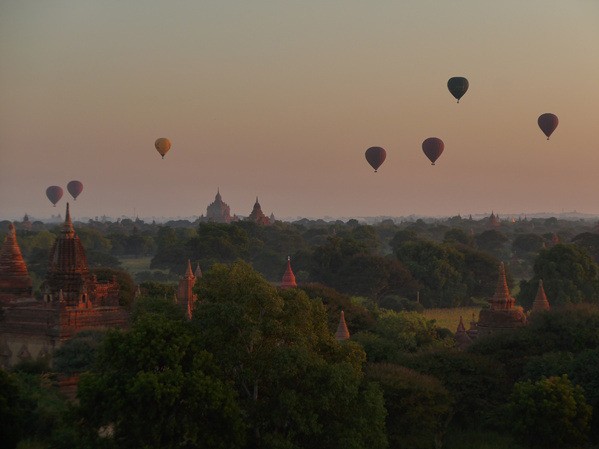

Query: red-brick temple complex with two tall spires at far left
[[0, 204, 128, 367]]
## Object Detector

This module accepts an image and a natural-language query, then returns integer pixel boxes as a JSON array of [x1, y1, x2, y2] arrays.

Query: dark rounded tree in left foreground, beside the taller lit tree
[[78, 315, 244, 448]]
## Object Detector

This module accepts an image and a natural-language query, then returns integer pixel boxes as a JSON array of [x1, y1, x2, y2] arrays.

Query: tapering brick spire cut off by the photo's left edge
[[0, 223, 33, 303]]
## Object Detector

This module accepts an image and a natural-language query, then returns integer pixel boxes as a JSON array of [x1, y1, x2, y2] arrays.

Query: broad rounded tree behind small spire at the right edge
[[518, 244, 599, 307]]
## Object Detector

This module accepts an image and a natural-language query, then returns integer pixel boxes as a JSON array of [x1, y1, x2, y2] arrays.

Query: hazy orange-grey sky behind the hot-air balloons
[[0, 0, 599, 218]]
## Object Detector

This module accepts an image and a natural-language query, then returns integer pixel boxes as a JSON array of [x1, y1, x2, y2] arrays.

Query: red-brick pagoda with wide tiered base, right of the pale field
[[476, 262, 526, 335]]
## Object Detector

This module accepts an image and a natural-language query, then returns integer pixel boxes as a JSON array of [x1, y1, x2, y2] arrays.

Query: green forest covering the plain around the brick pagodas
[[0, 216, 599, 449]]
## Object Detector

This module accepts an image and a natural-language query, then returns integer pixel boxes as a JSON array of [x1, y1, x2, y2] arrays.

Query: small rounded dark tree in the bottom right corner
[[509, 375, 592, 449]]
